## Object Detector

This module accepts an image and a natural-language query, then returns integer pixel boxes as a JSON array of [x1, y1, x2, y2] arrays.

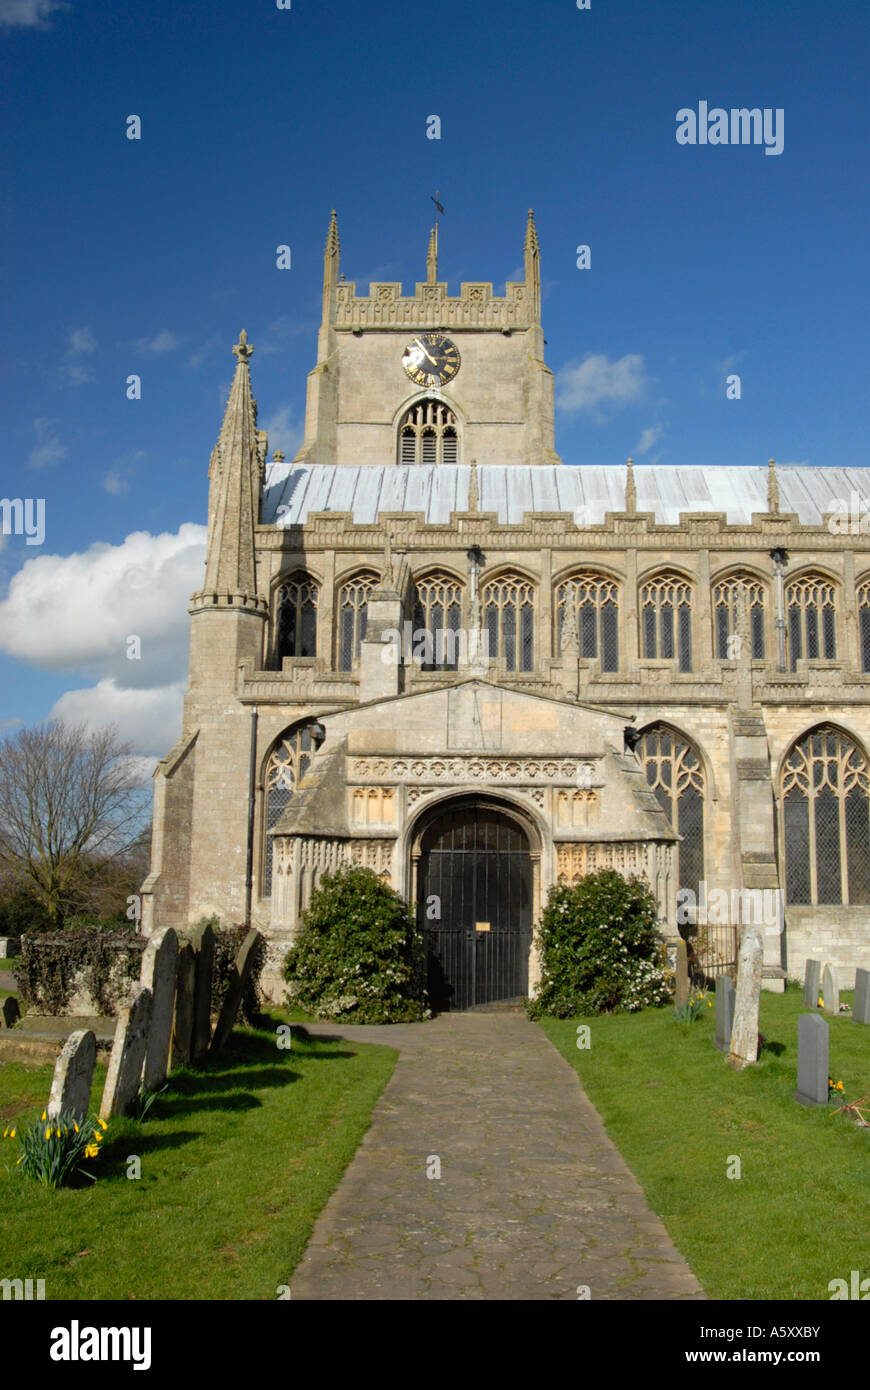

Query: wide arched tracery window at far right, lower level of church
[[780, 726, 870, 905]]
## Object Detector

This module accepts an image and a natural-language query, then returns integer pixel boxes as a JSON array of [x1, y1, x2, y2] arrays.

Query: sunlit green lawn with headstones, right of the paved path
[[541, 990, 870, 1300]]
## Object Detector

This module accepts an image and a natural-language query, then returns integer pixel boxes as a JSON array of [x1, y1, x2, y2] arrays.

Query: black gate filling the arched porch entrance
[[417, 802, 532, 1009]]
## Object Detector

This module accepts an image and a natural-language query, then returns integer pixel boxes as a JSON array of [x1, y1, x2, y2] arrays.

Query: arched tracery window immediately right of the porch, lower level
[[635, 724, 705, 902]]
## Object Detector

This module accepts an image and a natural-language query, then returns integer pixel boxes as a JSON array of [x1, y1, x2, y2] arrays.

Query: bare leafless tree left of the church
[[0, 720, 143, 924]]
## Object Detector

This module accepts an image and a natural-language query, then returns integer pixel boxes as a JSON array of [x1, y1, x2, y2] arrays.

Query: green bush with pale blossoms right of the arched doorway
[[528, 869, 670, 1019]]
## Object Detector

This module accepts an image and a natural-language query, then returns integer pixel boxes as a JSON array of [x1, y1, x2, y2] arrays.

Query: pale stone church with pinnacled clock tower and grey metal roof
[[143, 213, 870, 1008]]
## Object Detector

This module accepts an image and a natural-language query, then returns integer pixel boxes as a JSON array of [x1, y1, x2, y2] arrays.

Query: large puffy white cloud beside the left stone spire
[[0, 523, 206, 689]]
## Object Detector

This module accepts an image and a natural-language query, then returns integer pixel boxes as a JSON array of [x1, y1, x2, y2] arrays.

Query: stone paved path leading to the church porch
[[290, 1013, 705, 1300]]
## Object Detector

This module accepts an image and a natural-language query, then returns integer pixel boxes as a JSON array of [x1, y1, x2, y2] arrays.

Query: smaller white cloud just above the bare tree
[[49, 678, 185, 761]]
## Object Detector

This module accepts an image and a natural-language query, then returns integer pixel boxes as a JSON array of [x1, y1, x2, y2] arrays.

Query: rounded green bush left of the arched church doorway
[[284, 867, 431, 1023]]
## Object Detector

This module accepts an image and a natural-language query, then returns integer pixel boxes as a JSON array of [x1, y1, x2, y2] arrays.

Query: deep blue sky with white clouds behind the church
[[0, 0, 870, 759]]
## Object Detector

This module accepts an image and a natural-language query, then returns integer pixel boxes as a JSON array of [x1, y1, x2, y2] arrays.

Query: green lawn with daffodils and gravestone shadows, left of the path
[[0, 1013, 396, 1300]]
